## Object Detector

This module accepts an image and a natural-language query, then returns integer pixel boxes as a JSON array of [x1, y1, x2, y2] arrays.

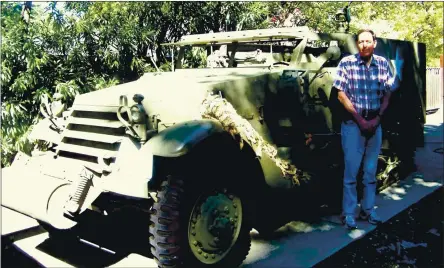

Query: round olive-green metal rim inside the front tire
[[188, 189, 242, 264]]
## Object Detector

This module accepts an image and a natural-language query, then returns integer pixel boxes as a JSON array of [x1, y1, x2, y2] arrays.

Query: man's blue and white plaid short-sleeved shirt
[[333, 54, 396, 114]]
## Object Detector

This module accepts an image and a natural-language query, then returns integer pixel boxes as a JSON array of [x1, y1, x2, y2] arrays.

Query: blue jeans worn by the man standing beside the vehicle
[[341, 120, 382, 216]]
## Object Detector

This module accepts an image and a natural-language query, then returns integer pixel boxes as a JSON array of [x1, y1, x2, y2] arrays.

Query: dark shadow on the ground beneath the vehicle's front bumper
[[22, 209, 152, 267]]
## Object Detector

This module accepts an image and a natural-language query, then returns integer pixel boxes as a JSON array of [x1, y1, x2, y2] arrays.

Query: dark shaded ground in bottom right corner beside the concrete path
[[315, 187, 444, 268]]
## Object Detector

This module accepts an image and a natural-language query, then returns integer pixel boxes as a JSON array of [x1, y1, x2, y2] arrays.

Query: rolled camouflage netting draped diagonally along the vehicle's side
[[201, 94, 299, 185]]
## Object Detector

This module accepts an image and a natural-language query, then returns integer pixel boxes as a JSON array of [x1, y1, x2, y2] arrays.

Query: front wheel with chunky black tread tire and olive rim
[[150, 176, 251, 268]]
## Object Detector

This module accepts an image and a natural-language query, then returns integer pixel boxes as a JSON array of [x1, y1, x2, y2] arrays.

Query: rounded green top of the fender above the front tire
[[145, 119, 225, 157]]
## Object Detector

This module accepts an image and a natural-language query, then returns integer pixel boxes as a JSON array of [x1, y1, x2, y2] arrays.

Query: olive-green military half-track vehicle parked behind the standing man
[[2, 27, 425, 267]]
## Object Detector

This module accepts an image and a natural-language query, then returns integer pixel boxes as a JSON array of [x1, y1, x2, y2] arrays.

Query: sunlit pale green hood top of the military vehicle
[[73, 68, 270, 127]]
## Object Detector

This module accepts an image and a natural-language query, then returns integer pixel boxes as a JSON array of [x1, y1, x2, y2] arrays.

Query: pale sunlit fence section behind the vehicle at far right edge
[[426, 67, 444, 110]]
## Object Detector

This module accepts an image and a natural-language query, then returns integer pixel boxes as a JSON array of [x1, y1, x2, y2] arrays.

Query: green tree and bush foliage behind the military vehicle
[[0, 1, 443, 166]]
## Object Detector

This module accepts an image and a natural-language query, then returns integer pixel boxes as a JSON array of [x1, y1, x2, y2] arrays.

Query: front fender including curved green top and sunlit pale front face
[[103, 120, 225, 199]]
